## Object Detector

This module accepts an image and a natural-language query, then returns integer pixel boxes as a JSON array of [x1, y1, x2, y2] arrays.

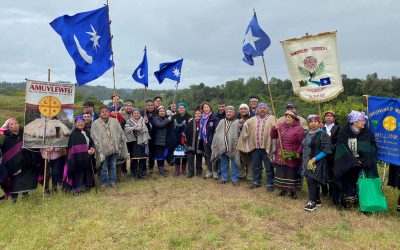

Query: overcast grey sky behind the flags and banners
[[0, 0, 400, 89]]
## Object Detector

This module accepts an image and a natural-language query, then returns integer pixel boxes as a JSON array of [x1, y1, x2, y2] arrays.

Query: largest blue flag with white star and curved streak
[[50, 5, 113, 86]]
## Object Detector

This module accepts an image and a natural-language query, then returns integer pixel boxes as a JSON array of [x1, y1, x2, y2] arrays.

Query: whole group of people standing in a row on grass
[[0, 93, 400, 211]]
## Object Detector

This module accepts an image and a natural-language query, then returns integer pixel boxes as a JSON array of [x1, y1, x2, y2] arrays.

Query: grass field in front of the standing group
[[0, 165, 400, 249]]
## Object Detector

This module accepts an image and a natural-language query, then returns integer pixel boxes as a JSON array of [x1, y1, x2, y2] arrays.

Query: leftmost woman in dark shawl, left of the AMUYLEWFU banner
[[1, 118, 38, 203]]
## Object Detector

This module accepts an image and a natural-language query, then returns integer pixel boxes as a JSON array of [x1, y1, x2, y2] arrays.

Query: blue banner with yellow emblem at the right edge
[[368, 96, 400, 165]]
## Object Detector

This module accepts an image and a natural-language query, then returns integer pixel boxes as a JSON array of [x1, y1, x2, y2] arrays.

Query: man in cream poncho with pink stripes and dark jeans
[[238, 103, 276, 192]]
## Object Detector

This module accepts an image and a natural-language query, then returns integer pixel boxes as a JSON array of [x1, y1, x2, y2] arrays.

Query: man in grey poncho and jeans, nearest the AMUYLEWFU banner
[[91, 106, 129, 189]]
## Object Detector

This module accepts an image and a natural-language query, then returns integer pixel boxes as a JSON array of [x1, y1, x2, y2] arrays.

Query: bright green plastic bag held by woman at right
[[358, 171, 387, 212]]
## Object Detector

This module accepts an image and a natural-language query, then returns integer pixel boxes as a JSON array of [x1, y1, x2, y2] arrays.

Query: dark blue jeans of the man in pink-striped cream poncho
[[251, 148, 274, 186]]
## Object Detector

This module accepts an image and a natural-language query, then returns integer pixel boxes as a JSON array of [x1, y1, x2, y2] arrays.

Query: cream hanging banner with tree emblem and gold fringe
[[281, 31, 343, 102]]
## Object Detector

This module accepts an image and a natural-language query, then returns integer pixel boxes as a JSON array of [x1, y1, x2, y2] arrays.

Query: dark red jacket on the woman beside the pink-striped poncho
[[271, 121, 305, 168]]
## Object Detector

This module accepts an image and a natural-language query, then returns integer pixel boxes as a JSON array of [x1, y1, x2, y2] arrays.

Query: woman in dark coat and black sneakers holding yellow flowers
[[301, 115, 332, 212]]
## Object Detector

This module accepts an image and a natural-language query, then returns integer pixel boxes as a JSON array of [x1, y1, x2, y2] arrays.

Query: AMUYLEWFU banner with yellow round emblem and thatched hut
[[23, 80, 75, 148]]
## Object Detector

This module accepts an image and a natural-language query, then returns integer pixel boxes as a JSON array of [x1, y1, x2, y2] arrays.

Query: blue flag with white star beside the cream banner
[[242, 13, 271, 65]]
